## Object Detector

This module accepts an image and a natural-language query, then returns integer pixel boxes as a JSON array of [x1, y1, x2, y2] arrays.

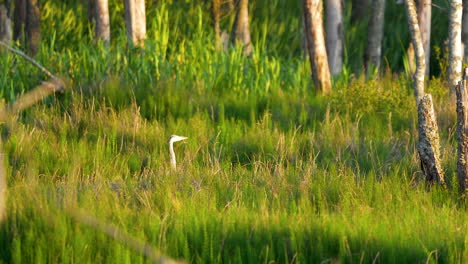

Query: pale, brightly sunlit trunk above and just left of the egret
[[124, 0, 146, 48]]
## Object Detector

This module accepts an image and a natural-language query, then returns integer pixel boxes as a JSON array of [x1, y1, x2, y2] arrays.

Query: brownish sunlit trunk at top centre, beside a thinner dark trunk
[[232, 0, 252, 56]]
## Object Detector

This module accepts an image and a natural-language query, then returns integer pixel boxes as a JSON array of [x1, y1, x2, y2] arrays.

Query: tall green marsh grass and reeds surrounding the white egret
[[0, 0, 468, 263]]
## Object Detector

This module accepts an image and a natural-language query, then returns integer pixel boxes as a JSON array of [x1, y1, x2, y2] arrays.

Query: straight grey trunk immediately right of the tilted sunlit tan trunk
[[326, 0, 344, 76]]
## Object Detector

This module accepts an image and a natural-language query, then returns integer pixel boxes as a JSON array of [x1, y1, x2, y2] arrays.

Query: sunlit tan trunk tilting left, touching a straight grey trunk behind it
[[302, 0, 331, 94]]
